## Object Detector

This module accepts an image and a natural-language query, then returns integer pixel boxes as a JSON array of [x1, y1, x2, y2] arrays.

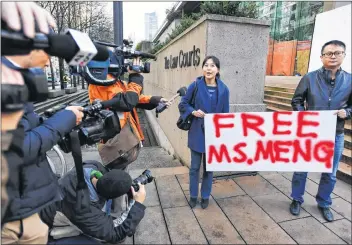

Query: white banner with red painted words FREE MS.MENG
[[204, 111, 337, 173]]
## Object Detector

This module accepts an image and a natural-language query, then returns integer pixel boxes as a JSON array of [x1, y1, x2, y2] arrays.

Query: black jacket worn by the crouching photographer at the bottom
[[40, 161, 145, 243]]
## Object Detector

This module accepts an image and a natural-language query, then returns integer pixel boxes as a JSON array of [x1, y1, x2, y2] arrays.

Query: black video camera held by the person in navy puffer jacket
[[44, 102, 121, 153]]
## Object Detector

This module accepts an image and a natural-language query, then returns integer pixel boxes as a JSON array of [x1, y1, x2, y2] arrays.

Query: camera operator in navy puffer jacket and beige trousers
[[1, 50, 83, 244]]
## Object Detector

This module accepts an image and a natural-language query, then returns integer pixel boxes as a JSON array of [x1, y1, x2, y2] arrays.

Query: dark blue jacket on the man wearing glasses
[[291, 68, 352, 134]]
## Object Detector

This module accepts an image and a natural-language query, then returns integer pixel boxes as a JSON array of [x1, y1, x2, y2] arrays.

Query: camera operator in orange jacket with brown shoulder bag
[[88, 58, 171, 214]]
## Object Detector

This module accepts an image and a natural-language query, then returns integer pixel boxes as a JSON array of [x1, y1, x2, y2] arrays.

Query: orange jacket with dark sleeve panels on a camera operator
[[88, 74, 161, 141]]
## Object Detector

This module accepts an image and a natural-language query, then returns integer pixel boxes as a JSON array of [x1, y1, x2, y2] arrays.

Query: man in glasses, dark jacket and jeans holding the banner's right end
[[290, 40, 352, 222]]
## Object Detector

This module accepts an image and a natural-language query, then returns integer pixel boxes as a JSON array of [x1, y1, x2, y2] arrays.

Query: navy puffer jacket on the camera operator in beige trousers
[[3, 103, 76, 223]]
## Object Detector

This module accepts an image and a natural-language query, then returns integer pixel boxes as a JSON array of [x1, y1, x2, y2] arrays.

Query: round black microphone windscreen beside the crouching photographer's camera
[[97, 169, 132, 199]]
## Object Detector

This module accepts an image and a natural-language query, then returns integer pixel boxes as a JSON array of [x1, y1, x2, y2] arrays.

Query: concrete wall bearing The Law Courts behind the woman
[[144, 15, 269, 165]]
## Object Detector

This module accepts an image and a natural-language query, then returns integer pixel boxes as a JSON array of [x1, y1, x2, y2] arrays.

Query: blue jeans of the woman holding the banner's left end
[[189, 150, 213, 199]]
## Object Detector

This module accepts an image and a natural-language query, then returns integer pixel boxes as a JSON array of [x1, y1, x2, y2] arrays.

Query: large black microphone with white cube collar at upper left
[[1, 29, 109, 66]]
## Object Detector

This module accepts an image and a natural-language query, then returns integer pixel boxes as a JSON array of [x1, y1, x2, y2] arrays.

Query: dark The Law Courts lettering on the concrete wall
[[164, 45, 200, 69]]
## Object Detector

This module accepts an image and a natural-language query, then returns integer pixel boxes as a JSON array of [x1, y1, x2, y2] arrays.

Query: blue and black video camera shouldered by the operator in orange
[[70, 40, 156, 86]]
